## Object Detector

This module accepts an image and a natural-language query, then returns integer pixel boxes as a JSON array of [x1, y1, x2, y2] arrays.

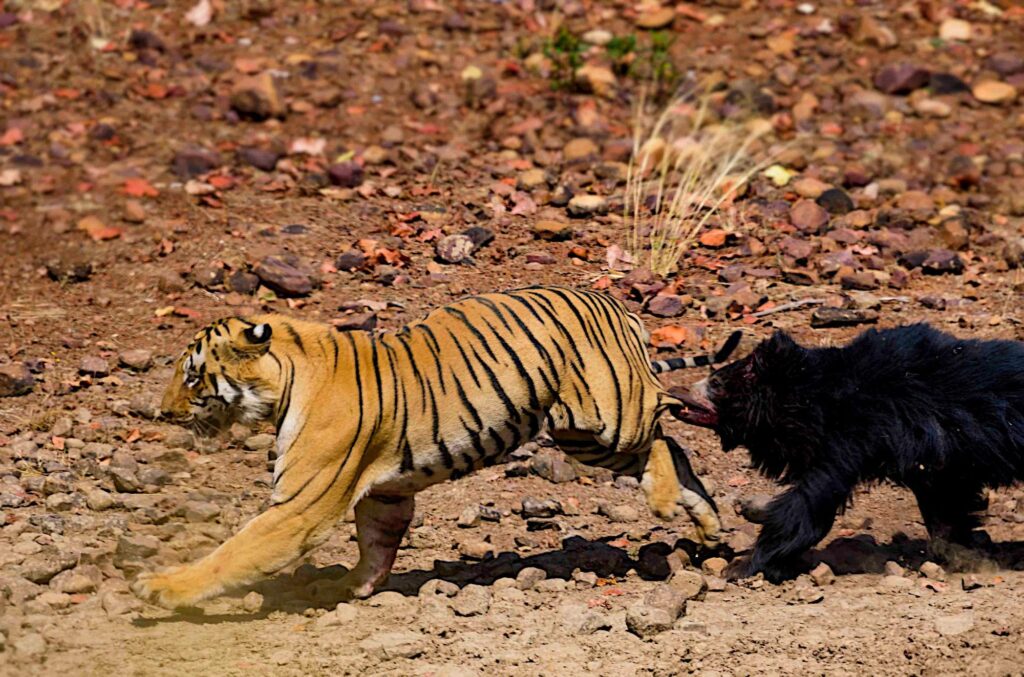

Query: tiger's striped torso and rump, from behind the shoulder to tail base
[[366, 287, 667, 491]]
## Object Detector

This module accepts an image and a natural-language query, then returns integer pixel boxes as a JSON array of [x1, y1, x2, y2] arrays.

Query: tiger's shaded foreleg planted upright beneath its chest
[[341, 495, 416, 599]]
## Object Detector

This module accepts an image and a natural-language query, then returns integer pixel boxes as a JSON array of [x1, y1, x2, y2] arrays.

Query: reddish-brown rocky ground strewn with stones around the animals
[[0, 0, 1024, 676]]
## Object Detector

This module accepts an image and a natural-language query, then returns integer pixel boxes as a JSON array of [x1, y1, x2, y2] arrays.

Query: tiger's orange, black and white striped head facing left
[[160, 318, 281, 434]]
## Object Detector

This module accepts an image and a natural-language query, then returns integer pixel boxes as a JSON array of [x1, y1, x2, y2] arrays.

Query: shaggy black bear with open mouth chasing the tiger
[[677, 324, 1024, 582]]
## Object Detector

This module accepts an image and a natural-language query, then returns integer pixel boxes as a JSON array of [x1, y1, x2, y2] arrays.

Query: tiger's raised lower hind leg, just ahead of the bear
[[640, 433, 722, 547]]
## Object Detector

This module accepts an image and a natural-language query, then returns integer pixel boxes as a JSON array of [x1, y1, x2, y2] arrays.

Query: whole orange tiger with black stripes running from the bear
[[133, 287, 738, 608]]
